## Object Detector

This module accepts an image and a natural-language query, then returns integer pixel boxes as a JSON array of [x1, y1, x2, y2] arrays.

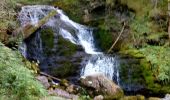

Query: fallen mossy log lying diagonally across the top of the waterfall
[[11, 10, 57, 40]]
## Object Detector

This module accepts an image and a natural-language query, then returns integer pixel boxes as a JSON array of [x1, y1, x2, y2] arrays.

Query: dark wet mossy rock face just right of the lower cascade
[[119, 58, 150, 91]]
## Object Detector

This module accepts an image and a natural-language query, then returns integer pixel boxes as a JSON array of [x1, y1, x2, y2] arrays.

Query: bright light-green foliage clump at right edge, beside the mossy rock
[[140, 46, 170, 83]]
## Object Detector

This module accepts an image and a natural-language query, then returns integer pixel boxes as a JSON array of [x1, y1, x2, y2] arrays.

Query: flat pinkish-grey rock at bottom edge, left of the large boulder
[[48, 89, 79, 100]]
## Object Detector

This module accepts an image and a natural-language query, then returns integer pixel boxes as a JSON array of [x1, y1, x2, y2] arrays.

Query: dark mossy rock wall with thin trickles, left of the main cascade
[[25, 27, 86, 79]]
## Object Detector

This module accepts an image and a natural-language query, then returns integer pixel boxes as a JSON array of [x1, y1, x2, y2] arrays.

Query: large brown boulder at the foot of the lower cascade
[[80, 74, 123, 99]]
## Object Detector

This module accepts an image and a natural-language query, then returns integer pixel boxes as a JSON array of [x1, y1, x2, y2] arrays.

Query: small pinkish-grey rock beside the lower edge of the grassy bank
[[36, 76, 50, 89]]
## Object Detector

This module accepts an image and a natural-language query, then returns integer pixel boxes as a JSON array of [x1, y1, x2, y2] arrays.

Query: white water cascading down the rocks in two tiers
[[19, 5, 119, 83]]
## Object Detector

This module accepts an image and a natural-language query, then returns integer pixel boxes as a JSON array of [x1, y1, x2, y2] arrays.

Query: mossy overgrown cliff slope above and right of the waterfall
[[54, 0, 170, 93]]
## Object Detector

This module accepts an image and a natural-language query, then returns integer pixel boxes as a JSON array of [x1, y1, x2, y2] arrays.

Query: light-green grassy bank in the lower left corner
[[0, 43, 46, 100]]
